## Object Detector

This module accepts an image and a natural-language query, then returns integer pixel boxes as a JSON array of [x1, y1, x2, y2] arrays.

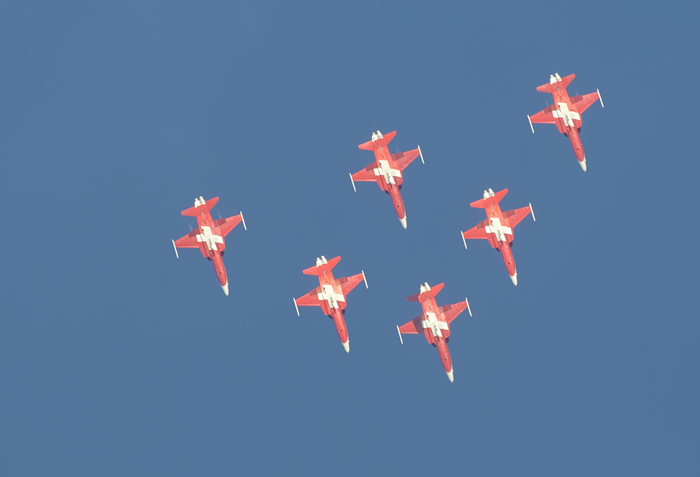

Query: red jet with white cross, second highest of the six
[[350, 131, 425, 228]]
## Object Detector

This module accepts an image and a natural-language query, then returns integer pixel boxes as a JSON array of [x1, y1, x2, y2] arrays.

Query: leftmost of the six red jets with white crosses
[[173, 196, 248, 296]]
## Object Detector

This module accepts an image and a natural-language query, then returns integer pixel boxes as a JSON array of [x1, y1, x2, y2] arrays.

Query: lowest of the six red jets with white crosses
[[396, 283, 472, 382]]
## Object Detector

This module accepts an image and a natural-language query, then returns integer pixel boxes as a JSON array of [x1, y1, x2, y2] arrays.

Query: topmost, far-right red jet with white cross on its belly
[[527, 73, 605, 172]]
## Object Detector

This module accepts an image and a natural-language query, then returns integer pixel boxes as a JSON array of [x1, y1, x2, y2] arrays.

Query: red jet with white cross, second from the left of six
[[294, 255, 369, 353]]
